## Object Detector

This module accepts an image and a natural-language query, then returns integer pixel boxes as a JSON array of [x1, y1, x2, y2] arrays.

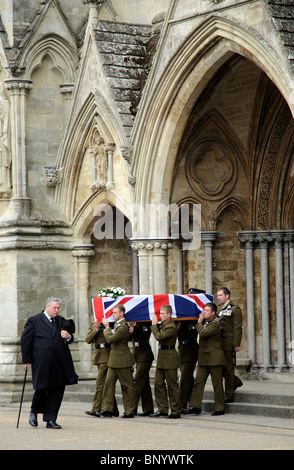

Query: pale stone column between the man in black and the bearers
[[72, 245, 95, 378]]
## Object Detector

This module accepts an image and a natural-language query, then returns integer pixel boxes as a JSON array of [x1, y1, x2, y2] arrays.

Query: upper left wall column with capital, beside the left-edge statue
[[5, 79, 32, 218]]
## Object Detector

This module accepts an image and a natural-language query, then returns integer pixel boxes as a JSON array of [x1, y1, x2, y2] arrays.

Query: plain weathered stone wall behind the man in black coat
[[0, 249, 78, 394]]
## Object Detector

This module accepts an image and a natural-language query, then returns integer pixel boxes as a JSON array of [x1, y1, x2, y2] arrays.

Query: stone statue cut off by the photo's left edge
[[0, 88, 11, 193]]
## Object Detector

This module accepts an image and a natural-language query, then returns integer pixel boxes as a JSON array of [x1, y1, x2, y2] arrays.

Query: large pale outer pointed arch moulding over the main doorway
[[133, 13, 291, 217]]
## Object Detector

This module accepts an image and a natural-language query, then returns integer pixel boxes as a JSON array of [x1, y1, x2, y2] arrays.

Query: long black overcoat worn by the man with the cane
[[21, 312, 78, 389]]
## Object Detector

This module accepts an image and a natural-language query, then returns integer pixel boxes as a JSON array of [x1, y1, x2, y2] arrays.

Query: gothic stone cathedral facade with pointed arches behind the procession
[[0, 0, 294, 400]]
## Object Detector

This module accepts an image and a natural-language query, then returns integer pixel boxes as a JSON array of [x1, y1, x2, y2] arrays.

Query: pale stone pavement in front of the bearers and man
[[0, 380, 294, 454]]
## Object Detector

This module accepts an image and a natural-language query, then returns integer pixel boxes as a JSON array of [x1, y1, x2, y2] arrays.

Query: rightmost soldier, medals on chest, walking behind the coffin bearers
[[217, 287, 243, 403]]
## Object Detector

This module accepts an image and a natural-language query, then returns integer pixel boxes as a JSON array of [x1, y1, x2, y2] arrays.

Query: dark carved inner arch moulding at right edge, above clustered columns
[[251, 83, 293, 230]]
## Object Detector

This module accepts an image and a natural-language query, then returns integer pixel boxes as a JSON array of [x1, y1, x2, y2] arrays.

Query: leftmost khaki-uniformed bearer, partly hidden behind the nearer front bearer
[[85, 320, 119, 417]]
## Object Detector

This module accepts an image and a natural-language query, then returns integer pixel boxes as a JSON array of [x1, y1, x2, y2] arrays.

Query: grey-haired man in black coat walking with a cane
[[21, 297, 78, 429]]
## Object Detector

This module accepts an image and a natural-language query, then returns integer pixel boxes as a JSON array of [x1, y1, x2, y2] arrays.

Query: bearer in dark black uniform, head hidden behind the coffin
[[178, 320, 198, 409]]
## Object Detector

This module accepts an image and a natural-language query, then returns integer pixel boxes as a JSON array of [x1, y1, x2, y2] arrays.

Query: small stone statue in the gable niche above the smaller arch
[[90, 136, 107, 190]]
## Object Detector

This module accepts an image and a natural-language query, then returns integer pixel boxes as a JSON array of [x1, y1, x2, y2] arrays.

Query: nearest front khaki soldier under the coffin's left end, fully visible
[[99, 304, 135, 418]]
